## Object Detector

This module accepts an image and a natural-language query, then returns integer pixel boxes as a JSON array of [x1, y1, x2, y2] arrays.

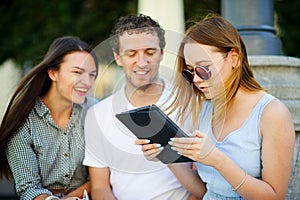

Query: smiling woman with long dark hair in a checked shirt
[[0, 36, 98, 200]]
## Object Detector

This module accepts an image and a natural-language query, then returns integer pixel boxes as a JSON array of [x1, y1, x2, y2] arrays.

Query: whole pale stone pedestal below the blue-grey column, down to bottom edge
[[249, 55, 300, 200]]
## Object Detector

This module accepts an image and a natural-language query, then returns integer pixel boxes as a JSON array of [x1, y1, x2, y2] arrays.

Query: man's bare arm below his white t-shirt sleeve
[[89, 167, 116, 200]]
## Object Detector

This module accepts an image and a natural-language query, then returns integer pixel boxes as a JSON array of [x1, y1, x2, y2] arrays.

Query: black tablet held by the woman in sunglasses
[[116, 104, 193, 164]]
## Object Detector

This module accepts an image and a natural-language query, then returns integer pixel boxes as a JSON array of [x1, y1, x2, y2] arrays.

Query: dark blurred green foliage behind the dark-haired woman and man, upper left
[[0, 0, 136, 68]]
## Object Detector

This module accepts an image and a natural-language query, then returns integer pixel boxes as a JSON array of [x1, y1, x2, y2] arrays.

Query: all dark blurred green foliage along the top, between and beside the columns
[[0, 0, 300, 68]]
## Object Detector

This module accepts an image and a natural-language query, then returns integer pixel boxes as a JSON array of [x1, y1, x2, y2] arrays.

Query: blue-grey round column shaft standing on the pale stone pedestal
[[221, 0, 282, 55]]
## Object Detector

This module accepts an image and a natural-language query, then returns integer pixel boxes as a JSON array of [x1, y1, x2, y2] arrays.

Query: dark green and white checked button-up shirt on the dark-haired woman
[[6, 99, 94, 200]]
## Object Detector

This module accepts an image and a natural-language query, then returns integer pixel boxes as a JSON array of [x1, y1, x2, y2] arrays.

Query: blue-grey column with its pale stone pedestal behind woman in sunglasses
[[221, 0, 300, 197]]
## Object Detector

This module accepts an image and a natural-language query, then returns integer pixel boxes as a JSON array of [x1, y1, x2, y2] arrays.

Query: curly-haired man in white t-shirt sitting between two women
[[83, 14, 189, 200]]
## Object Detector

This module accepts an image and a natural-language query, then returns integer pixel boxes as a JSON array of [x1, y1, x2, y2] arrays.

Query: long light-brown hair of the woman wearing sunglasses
[[167, 14, 266, 129]]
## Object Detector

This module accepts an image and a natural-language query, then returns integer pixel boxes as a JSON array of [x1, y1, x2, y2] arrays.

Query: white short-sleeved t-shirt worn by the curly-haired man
[[83, 80, 189, 200]]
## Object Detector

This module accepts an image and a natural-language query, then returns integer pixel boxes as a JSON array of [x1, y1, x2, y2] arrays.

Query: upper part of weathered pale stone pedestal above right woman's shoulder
[[249, 55, 300, 132]]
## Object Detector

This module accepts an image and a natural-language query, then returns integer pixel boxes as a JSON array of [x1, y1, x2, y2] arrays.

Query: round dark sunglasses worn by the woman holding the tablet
[[181, 57, 225, 83]]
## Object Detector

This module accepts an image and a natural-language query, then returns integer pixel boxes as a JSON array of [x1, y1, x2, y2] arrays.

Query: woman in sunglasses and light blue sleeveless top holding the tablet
[[136, 16, 295, 200]]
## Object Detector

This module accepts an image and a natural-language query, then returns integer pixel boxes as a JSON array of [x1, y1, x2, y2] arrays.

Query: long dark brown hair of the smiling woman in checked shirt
[[0, 36, 98, 179]]
